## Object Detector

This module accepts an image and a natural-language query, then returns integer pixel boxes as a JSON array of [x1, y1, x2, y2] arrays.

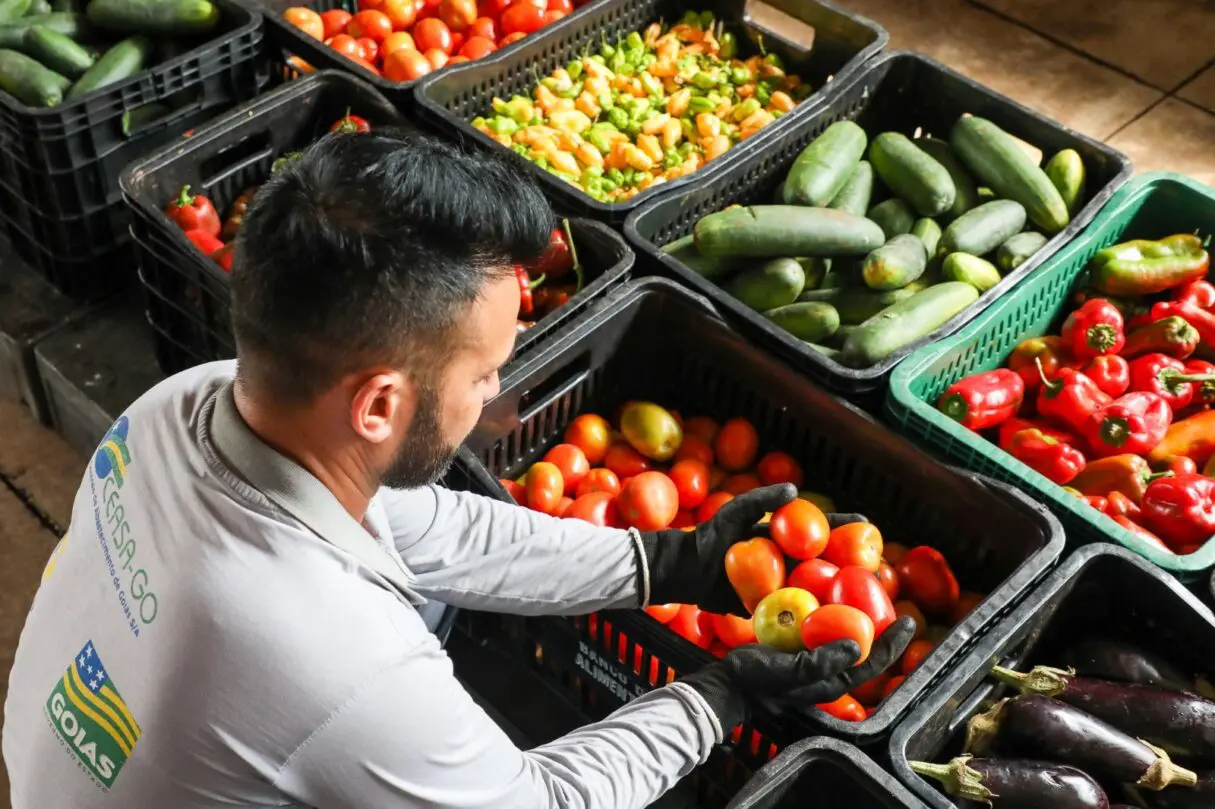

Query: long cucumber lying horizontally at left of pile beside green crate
[[695, 205, 886, 258]]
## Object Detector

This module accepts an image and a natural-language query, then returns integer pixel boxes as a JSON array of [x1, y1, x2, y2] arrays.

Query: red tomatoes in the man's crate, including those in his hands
[[501, 402, 983, 722]]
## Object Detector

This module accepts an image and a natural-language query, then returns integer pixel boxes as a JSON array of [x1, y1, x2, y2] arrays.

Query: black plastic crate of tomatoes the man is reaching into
[[456, 278, 1063, 749]]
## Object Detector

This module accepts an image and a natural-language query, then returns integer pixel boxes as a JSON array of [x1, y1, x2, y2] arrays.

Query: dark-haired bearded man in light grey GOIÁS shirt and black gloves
[[4, 134, 909, 809]]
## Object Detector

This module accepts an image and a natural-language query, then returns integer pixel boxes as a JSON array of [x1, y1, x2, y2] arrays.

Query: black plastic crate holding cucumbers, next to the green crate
[[625, 51, 1131, 403]]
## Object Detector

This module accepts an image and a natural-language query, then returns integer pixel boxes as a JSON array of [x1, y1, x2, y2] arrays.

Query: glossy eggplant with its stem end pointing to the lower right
[[966, 694, 1198, 790]]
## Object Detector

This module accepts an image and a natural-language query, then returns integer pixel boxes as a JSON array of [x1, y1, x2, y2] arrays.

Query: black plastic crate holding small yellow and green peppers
[[414, 0, 889, 225]]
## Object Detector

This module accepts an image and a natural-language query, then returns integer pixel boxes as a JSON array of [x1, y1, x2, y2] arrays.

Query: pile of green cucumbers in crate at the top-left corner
[[0, 0, 220, 107]]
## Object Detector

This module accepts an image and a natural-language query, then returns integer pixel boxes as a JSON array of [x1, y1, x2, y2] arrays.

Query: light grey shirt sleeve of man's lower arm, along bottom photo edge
[[276, 643, 722, 809]]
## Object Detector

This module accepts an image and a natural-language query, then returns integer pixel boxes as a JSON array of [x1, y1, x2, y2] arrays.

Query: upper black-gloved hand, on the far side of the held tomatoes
[[642, 483, 868, 616]]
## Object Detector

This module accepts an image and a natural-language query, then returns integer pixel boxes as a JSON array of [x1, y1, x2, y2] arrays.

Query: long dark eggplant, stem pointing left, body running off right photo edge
[[991, 666, 1215, 766]]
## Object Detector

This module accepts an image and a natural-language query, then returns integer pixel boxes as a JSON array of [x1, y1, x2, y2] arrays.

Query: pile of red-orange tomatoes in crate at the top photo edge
[[283, 0, 583, 81]]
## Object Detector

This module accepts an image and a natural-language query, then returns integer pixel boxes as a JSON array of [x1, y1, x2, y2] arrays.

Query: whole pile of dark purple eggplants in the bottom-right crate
[[910, 640, 1215, 809]]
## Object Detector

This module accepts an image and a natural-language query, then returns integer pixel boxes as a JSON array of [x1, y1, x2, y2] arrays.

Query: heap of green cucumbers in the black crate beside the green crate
[[663, 115, 1085, 368]]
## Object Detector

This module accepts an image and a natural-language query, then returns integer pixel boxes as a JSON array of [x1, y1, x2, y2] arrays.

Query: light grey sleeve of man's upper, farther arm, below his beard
[[379, 486, 649, 615]]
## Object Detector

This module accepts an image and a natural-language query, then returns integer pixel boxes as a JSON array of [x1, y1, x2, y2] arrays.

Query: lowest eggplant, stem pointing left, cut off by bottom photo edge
[[909, 756, 1109, 809]]
